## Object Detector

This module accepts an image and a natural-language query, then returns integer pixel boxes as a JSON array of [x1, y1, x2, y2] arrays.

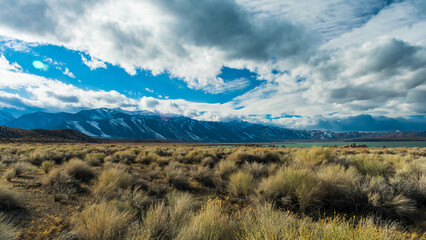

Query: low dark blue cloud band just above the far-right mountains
[[312, 115, 426, 131]]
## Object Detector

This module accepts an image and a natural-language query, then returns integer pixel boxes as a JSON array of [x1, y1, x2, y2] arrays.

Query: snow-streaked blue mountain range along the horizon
[[0, 108, 426, 142]]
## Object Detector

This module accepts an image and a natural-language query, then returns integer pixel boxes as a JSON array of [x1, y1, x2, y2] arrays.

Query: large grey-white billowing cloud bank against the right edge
[[316, 39, 426, 114]]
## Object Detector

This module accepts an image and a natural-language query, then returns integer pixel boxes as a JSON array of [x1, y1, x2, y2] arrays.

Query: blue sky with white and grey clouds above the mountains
[[0, 0, 426, 131]]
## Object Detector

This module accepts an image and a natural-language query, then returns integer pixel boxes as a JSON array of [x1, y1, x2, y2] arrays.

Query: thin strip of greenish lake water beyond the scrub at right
[[265, 141, 426, 148]]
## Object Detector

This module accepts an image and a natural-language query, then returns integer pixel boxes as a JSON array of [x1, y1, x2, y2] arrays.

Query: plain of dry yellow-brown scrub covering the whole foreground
[[0, 144, 426, 240]]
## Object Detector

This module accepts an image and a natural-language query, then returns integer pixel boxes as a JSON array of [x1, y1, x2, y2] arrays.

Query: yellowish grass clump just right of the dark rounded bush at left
[[93, 167, 133, 199]]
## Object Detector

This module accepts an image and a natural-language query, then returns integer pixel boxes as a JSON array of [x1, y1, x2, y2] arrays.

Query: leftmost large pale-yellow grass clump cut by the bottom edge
[[71, 202, 133, 240]]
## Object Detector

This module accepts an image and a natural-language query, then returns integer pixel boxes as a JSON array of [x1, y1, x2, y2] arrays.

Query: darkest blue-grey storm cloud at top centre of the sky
[[155, 0, 319, 60]]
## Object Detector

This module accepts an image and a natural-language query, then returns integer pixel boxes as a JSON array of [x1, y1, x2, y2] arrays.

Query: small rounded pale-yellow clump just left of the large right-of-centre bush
[[229, 170, 256, 197]]
